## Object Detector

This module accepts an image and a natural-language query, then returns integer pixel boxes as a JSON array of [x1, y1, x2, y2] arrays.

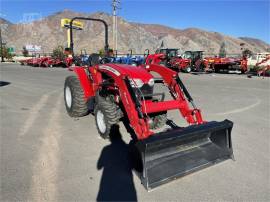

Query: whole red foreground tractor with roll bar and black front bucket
[[64, 17, 233, 190]]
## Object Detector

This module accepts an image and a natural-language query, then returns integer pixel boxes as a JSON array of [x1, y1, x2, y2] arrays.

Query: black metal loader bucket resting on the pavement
[[135, 120, 233, 190]]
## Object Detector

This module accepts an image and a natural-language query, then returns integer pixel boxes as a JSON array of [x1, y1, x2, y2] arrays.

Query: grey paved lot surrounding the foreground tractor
[[0, 64, 270, 201]]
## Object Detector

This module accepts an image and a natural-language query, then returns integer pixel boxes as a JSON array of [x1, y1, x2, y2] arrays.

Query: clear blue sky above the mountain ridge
[[0, 0, 270, 43]]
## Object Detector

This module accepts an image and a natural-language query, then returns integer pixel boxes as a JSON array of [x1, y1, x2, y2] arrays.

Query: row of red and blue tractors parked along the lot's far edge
[[20, 45, 270, 76]]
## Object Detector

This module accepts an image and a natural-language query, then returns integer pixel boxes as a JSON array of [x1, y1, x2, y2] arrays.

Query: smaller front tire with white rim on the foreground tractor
[[94, 95, 122, 139]]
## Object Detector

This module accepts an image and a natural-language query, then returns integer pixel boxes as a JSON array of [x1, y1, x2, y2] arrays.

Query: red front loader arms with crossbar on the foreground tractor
[[98, 64, 204, 140]]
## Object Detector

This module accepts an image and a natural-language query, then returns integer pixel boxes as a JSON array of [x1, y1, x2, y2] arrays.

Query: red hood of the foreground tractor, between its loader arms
[[99, 63, 153, 83]]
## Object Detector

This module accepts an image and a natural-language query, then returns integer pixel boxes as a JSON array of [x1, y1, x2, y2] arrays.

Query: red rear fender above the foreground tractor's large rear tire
[[73, 67, 95, 101]]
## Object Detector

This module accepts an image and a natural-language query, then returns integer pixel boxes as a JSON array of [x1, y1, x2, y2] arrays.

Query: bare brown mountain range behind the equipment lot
[[0, 10, 270, 55]]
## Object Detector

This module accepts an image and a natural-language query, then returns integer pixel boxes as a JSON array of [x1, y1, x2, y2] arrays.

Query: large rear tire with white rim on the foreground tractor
[[64, 76, 88, 117]]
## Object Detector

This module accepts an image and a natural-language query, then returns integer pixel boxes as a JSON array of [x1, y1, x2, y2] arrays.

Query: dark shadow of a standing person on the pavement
[[97, 126, 137, 201]]
